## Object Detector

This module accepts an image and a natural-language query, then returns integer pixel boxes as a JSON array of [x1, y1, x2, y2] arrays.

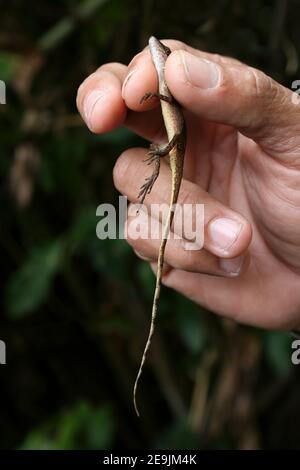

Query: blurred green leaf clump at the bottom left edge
[[21, 402, 115, 450]]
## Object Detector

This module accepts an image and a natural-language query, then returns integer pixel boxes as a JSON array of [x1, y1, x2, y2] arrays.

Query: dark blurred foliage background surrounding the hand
[[0, 0, 300, 449]]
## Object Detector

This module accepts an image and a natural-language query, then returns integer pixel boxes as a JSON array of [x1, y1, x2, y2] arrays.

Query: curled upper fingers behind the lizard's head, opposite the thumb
[[77, 41, 247, 142]]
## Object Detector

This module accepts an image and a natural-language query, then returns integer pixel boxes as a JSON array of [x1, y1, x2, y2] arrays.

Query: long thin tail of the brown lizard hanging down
[[133, 204, 174, 417]]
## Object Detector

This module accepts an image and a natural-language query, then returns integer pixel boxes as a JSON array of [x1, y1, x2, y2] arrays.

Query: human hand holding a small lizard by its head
[[77, 41, 300, 329]]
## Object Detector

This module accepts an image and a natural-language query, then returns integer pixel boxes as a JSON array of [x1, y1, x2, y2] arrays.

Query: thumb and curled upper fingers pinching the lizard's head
[[77, 41, 300, 160]]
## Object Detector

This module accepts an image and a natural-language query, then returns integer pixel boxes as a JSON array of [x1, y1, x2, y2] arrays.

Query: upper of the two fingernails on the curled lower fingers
[[208, 217, 242, 252]]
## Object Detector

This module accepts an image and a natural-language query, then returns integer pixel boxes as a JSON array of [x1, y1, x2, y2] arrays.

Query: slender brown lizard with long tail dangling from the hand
[[133, 36, 186, 416]]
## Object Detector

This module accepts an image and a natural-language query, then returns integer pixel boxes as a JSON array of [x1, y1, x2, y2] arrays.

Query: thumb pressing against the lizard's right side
[[165, 50, 300, 160]]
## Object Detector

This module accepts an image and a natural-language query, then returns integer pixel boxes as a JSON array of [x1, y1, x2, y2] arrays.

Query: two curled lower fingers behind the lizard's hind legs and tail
[[114, 149, 251, 274]]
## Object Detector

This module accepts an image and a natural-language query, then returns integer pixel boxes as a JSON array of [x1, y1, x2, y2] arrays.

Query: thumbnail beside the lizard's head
[[180, 51, 221, 88]]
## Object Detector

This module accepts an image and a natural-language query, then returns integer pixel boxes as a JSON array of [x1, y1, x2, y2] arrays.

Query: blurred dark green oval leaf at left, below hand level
[[6, 240, 64, 318]]
